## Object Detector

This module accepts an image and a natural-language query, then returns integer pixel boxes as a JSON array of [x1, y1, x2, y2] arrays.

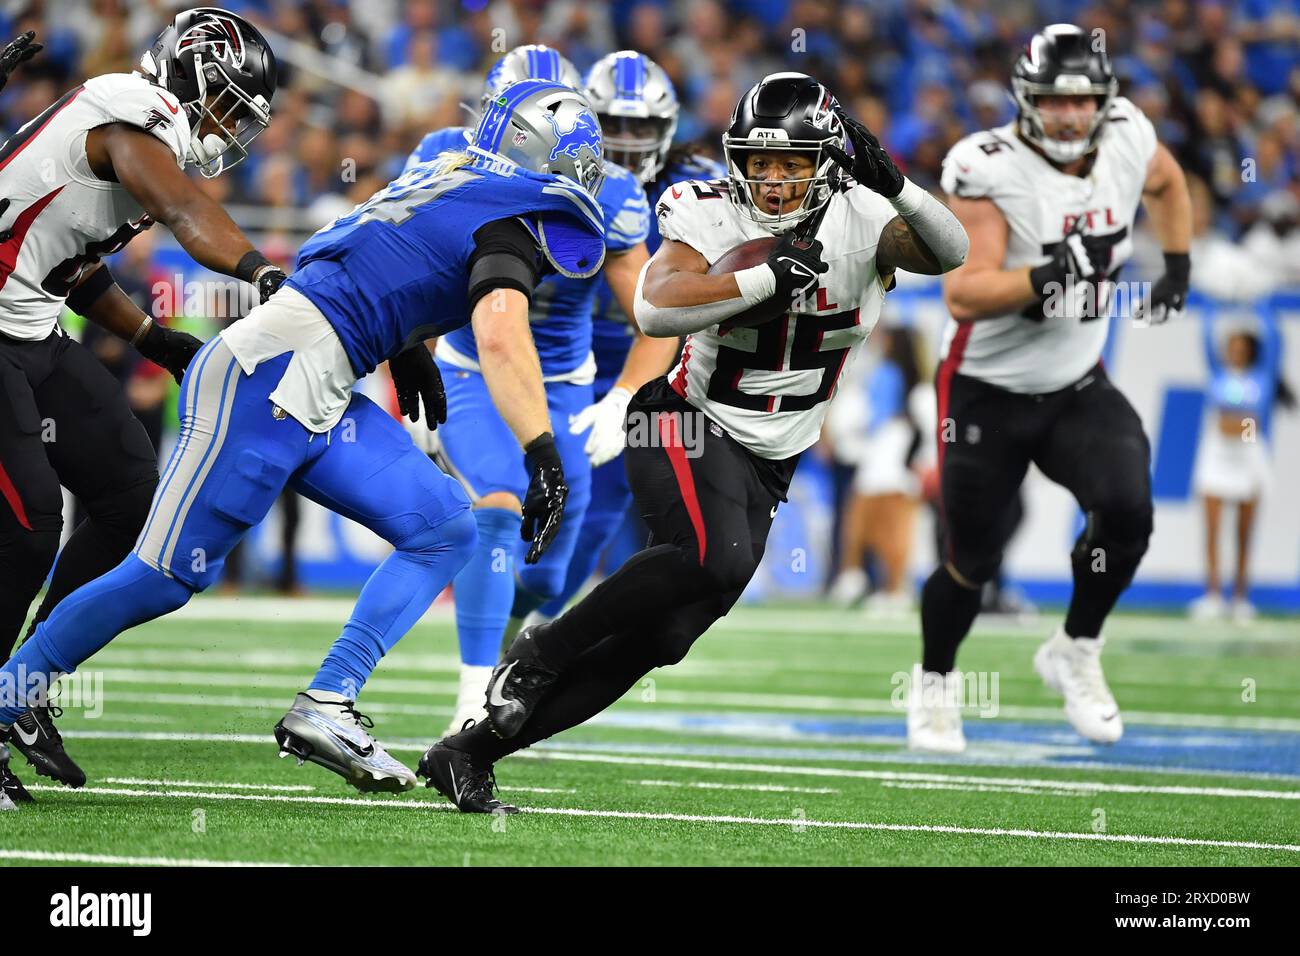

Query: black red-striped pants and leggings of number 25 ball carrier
[[454, 378, 798, 761]]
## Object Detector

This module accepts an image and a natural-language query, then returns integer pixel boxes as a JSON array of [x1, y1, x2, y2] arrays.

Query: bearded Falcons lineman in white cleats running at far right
[[907, 23, 1191, 752]]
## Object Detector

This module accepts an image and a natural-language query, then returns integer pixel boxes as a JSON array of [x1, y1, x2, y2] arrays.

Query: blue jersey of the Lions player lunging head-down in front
[[287, 160, 605, 376]]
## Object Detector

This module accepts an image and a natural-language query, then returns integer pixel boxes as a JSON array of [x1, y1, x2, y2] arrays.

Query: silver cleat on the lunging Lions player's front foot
[[276, 691, 416, 793]]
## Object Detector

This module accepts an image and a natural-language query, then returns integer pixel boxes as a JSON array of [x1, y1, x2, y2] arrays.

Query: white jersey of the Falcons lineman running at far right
[[943, 96, 1156, 394]]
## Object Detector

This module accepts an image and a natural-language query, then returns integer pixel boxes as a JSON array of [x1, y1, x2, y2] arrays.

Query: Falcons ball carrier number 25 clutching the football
[[420, 73, 967, 813]]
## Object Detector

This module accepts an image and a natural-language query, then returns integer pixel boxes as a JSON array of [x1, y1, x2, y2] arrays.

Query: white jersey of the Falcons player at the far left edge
[[0, 73, 190, 339]]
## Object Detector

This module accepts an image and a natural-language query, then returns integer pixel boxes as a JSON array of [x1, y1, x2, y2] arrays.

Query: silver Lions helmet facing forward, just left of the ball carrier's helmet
[[582, 49, 680, 183]]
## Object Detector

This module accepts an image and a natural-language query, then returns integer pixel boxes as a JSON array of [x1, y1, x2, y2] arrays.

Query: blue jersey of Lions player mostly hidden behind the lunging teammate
[[407, 126, 654, 376]]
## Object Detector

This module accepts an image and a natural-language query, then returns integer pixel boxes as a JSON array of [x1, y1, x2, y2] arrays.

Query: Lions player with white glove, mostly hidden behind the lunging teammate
[[410, 44, 660, 732]]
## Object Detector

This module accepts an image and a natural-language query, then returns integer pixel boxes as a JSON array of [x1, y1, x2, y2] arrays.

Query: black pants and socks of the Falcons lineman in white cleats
[[920, 364, 1153, 672]]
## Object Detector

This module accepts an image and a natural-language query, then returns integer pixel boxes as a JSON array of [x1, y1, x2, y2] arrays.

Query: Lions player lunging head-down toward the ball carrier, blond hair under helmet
[[0, 81, 605, 791]]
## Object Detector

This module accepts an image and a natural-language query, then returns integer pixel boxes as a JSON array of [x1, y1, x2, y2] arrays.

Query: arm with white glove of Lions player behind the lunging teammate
[[569, 242, 677, 468]]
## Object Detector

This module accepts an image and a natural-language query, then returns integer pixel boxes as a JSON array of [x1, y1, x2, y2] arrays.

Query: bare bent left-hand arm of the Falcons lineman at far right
[[944, 195, 1040, 323]]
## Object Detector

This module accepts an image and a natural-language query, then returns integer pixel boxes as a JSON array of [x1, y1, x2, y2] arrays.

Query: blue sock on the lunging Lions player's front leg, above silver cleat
[[309, 511, 478, 700]]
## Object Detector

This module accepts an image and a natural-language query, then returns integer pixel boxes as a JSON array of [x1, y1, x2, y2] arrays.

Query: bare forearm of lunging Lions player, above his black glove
[[471, 289, 553, 447]]
